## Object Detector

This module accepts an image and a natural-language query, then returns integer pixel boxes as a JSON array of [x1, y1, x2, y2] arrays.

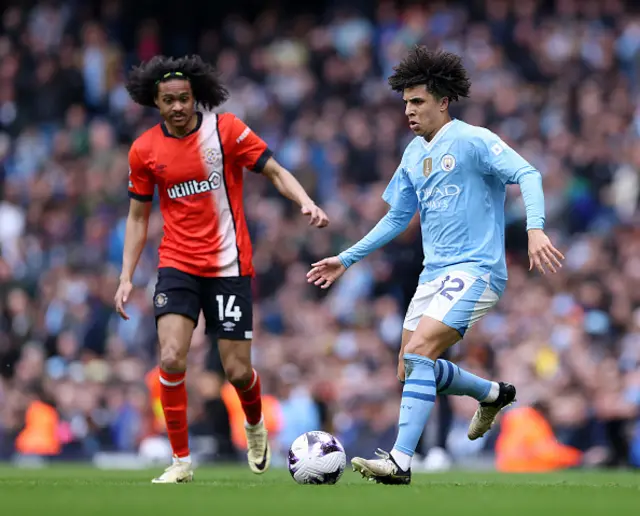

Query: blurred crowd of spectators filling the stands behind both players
[[0, 0, 640, 466]]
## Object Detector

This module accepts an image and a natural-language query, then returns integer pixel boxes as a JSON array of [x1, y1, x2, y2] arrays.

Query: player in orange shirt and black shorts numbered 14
[[115, 56, 329, 483]]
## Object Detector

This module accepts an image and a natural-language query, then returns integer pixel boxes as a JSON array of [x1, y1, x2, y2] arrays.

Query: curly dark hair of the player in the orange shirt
[[126, 55, 229, 109]]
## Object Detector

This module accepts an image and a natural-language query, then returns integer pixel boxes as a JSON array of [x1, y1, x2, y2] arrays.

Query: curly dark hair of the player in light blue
[[389, 46, 471, 102]]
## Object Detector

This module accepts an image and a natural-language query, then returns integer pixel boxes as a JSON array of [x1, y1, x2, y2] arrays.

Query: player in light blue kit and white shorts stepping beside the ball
[[307, 47, 564, 484]]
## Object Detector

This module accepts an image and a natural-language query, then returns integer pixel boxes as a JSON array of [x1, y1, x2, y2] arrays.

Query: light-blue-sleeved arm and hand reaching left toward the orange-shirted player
[[307, 208, 413, 289]]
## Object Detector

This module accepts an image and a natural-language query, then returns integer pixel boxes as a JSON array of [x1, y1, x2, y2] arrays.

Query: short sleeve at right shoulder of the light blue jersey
[[472, 130, 535, 184]]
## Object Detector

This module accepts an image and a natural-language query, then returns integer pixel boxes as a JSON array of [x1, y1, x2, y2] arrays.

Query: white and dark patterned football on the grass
[[288, 431, 347, 485]]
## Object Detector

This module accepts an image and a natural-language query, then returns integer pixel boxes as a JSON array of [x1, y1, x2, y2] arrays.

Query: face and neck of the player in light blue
[[402, 84, 449, 140]]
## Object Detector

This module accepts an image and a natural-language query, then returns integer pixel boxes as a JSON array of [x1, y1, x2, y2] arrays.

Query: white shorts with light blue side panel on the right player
[[404, 271, 500, 336]]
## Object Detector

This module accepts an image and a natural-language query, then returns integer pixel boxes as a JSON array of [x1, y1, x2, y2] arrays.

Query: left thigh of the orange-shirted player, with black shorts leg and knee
[[153, 268, 200, 371]]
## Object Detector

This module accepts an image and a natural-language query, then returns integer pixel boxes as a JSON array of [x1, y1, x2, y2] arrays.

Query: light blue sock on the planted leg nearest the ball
[[393, 353, 436, 460]]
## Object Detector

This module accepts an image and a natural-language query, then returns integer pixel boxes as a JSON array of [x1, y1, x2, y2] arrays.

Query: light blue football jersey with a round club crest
[[382, 119, 544, 294]]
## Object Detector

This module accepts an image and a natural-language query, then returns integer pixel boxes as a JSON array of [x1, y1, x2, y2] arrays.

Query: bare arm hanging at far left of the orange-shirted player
[[114, 199, 151, 321]]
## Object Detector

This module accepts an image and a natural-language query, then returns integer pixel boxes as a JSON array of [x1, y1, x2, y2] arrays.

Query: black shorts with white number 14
[[153, 267, 253, 340]]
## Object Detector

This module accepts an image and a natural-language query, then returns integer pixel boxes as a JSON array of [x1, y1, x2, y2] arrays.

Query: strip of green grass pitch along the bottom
[[0, 466, 640, 516]]
